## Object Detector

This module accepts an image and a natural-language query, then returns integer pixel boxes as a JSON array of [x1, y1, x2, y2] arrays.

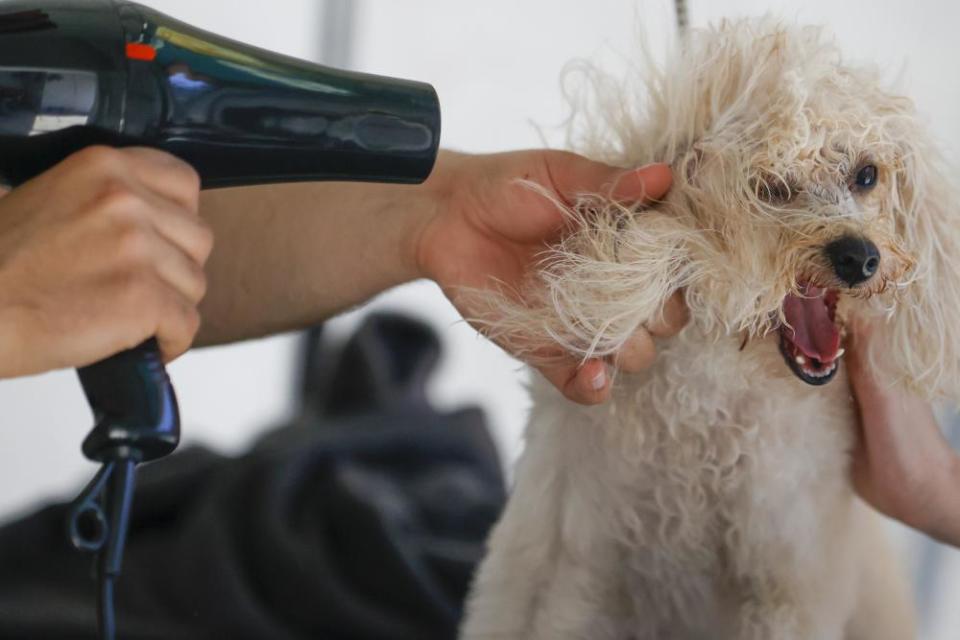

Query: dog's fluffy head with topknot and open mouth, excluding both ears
[[638, 21, 928, 385]]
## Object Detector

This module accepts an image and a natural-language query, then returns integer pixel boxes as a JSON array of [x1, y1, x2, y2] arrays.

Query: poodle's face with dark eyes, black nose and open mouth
[[756, 137, 913, 385]]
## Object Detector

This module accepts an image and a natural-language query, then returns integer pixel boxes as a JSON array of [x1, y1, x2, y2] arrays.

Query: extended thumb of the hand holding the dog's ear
[[546, 152, 673, 202]]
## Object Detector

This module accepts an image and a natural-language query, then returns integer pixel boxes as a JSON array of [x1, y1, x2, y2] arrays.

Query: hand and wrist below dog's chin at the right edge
[[846, 322, 960, 546]]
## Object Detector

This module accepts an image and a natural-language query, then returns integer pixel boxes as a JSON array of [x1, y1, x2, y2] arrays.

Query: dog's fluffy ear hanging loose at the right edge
[[871, 127, 960, 401]]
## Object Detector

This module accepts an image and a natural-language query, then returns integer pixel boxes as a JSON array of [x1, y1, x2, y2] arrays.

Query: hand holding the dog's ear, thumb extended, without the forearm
[[416, 151, 687, 404]]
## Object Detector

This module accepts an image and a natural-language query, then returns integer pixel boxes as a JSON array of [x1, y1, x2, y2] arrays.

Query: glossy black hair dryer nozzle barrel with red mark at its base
[[121, 4, 440, 186]]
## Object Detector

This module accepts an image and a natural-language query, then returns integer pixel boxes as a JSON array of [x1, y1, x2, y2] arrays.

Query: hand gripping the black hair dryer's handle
[[0, 147, 213, 377]]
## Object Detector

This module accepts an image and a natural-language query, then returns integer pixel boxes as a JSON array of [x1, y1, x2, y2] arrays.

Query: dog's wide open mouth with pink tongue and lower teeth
[[780, 285, 843, 385]]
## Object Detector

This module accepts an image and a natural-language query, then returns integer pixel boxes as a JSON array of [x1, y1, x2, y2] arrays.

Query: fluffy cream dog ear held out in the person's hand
[[462, 196, 690, 365]]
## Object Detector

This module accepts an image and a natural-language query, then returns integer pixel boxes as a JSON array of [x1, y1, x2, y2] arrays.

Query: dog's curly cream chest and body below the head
[[463, 329, 912, 640]]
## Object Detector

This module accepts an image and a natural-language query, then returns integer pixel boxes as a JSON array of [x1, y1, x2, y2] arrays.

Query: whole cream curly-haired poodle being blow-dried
[[461, 18, 960, 640]]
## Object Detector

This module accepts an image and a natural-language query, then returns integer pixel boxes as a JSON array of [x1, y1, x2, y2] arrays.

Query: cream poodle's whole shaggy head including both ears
[[480, 19, 960, 396]]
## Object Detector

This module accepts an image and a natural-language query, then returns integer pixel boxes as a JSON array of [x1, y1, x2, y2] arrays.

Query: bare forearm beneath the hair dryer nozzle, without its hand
[[197, 153, 451, 345]]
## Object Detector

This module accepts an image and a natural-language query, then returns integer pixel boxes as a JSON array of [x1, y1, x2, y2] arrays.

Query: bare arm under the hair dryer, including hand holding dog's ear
[[199, 151, 686, 403]]
